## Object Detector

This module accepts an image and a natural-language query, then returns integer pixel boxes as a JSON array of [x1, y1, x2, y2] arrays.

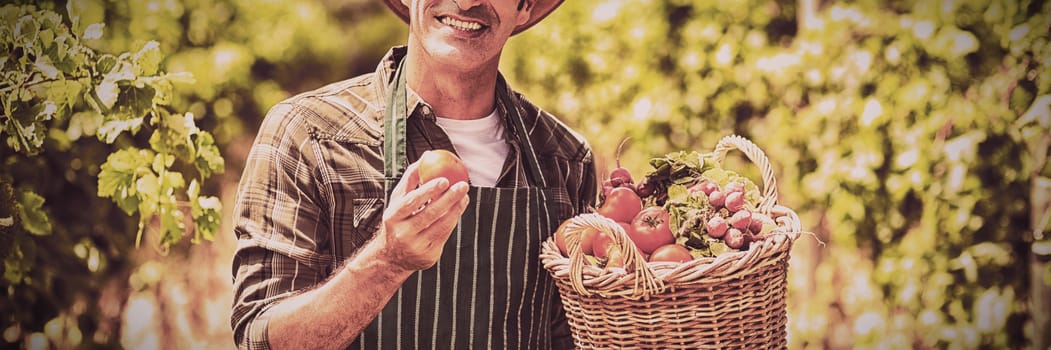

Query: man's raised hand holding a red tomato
[[378, 159, 469, 271]]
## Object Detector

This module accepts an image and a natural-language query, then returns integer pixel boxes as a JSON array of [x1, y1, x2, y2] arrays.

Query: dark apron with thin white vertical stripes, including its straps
[[350, 60, 561, 349]]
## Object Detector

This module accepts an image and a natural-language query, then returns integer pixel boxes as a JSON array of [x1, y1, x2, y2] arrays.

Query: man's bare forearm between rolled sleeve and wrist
[[265, 242, 413, 349]]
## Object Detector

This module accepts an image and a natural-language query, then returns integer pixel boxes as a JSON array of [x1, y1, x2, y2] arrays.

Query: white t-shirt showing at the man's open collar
[[436, 108, 509, 187]]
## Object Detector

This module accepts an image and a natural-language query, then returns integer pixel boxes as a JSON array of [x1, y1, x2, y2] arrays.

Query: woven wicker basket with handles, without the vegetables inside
[[540, 136, 801, 349]]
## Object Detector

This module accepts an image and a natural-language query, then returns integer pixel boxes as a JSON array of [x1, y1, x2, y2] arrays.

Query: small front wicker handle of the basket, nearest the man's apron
[[564, 212, 664, 300]]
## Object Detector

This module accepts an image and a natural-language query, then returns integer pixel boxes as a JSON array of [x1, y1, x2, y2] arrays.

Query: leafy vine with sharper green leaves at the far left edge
[[0, 3, 224, 346]]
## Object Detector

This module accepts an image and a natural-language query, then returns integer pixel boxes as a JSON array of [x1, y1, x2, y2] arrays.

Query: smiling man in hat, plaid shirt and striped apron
[[231, 0, 597, 349]]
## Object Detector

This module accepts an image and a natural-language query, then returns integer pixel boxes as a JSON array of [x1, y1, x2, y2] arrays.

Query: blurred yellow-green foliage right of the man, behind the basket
[[502, 0, 1051, 349]]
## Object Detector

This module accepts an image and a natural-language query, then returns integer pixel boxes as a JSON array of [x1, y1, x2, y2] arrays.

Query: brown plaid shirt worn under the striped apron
[[231, 47, 597, 349]]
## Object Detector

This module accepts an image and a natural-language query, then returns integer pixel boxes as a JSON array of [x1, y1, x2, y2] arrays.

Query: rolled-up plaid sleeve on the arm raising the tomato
[[230, 103, 332, 349]]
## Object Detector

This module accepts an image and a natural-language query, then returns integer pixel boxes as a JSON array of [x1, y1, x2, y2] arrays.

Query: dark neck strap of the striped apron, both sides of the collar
[[384, 58, 548, 188]]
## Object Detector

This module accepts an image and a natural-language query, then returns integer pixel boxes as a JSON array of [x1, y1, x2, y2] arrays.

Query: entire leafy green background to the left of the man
[[0, 0, 404, 348]]
